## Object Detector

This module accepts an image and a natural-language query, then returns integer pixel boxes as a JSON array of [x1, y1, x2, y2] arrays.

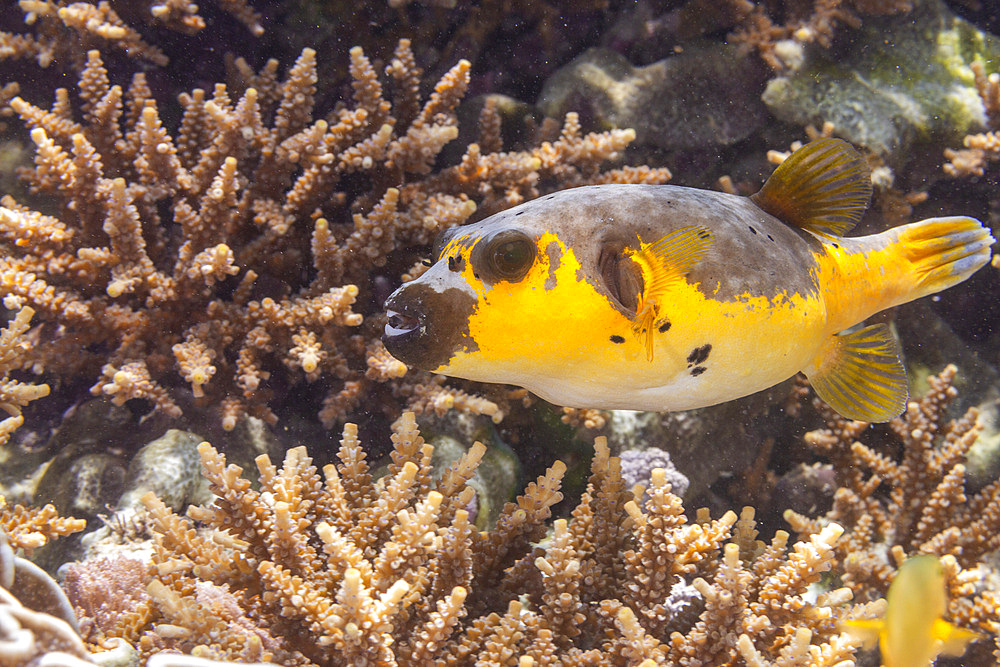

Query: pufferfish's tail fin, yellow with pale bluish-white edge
[[894, 216, 996, 298]]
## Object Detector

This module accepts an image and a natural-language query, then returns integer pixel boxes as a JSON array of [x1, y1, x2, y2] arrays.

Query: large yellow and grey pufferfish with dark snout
[[383, 138, 994, 422]]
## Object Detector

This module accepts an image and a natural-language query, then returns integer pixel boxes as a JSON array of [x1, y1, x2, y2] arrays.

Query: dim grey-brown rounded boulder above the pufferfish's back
[[538, 45, 767, 150]]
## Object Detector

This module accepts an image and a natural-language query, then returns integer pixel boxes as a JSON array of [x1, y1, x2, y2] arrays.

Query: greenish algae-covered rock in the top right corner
[[763, 0, 1000, 157]]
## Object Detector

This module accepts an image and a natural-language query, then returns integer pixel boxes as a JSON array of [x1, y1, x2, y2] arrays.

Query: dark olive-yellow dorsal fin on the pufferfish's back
[[750, 137, 872, 236]]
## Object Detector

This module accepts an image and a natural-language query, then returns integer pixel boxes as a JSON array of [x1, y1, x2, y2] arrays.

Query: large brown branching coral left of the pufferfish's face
[[0, 40, 669, 428]]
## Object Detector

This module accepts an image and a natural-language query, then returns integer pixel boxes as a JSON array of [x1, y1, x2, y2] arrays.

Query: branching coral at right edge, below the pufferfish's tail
[[785, 365, 1000, 659]]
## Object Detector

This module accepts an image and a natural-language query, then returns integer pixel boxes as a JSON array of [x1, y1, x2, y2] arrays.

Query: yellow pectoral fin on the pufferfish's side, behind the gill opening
[[624, 225, 712, 361]]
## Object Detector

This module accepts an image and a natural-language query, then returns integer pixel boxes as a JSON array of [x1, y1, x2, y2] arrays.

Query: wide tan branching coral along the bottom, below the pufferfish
[[70, 414, 877, 665]]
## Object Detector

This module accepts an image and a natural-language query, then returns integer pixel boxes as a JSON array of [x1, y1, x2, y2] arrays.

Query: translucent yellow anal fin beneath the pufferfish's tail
[[803, 324, 908, 422]]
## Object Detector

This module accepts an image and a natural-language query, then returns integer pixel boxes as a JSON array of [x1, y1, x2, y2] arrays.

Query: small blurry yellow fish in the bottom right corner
[[843, 554, 982, 667]]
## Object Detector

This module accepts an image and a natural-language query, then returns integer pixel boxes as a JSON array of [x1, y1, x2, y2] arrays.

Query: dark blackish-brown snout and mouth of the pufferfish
[[382, 262, 477, 371]]
